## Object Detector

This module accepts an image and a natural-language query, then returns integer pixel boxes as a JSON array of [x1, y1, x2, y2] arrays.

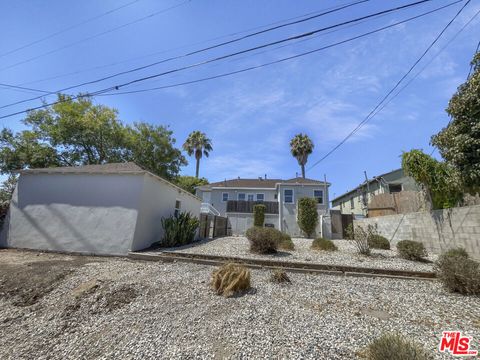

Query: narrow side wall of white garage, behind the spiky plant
[[132, 174, 201, 250]]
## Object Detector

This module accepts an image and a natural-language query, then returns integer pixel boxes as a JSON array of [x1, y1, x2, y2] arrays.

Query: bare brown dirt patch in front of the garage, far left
[[0, 255, 94, 306]]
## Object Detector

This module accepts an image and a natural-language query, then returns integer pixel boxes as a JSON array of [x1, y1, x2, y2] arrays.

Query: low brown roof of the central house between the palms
[[198, 177, 330, 190]]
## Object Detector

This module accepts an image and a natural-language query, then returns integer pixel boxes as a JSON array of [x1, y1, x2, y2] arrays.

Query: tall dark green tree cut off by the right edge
[[432, 52, 480, 195]]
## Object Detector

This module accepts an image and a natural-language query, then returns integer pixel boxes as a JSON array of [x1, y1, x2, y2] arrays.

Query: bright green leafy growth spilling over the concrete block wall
[[402, 150, 463, 209]]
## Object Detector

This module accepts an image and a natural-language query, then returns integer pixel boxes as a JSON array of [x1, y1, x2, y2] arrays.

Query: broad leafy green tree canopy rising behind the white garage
[[0, 95, 187, 179]]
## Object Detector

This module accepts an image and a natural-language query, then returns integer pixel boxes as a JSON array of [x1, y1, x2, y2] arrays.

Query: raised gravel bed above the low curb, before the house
[[168, 236, 436, 271]]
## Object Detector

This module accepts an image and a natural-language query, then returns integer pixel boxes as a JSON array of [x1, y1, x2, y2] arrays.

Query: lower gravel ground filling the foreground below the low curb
[[0, 251, 480, 359]]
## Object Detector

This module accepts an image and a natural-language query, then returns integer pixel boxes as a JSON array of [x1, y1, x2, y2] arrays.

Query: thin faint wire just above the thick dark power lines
[[19, 2, 374, 85]]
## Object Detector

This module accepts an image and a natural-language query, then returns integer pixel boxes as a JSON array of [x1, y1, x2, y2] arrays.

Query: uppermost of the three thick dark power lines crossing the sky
[[0, 0, 372, 109]]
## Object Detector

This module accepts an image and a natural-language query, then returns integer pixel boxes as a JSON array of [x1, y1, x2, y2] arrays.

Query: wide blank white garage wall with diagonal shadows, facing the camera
[[2, 174, 144, 255]]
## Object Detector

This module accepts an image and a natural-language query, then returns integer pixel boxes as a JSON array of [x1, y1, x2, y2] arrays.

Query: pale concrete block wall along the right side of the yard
[[354, 205, 480, 260]]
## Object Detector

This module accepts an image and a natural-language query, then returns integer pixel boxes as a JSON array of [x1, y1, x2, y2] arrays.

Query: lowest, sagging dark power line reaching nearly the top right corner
[[97, 0, 463, 96]]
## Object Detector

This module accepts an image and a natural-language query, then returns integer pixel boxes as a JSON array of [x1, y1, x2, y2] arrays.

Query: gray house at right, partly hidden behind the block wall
[[332, 169, 421, 216]]
